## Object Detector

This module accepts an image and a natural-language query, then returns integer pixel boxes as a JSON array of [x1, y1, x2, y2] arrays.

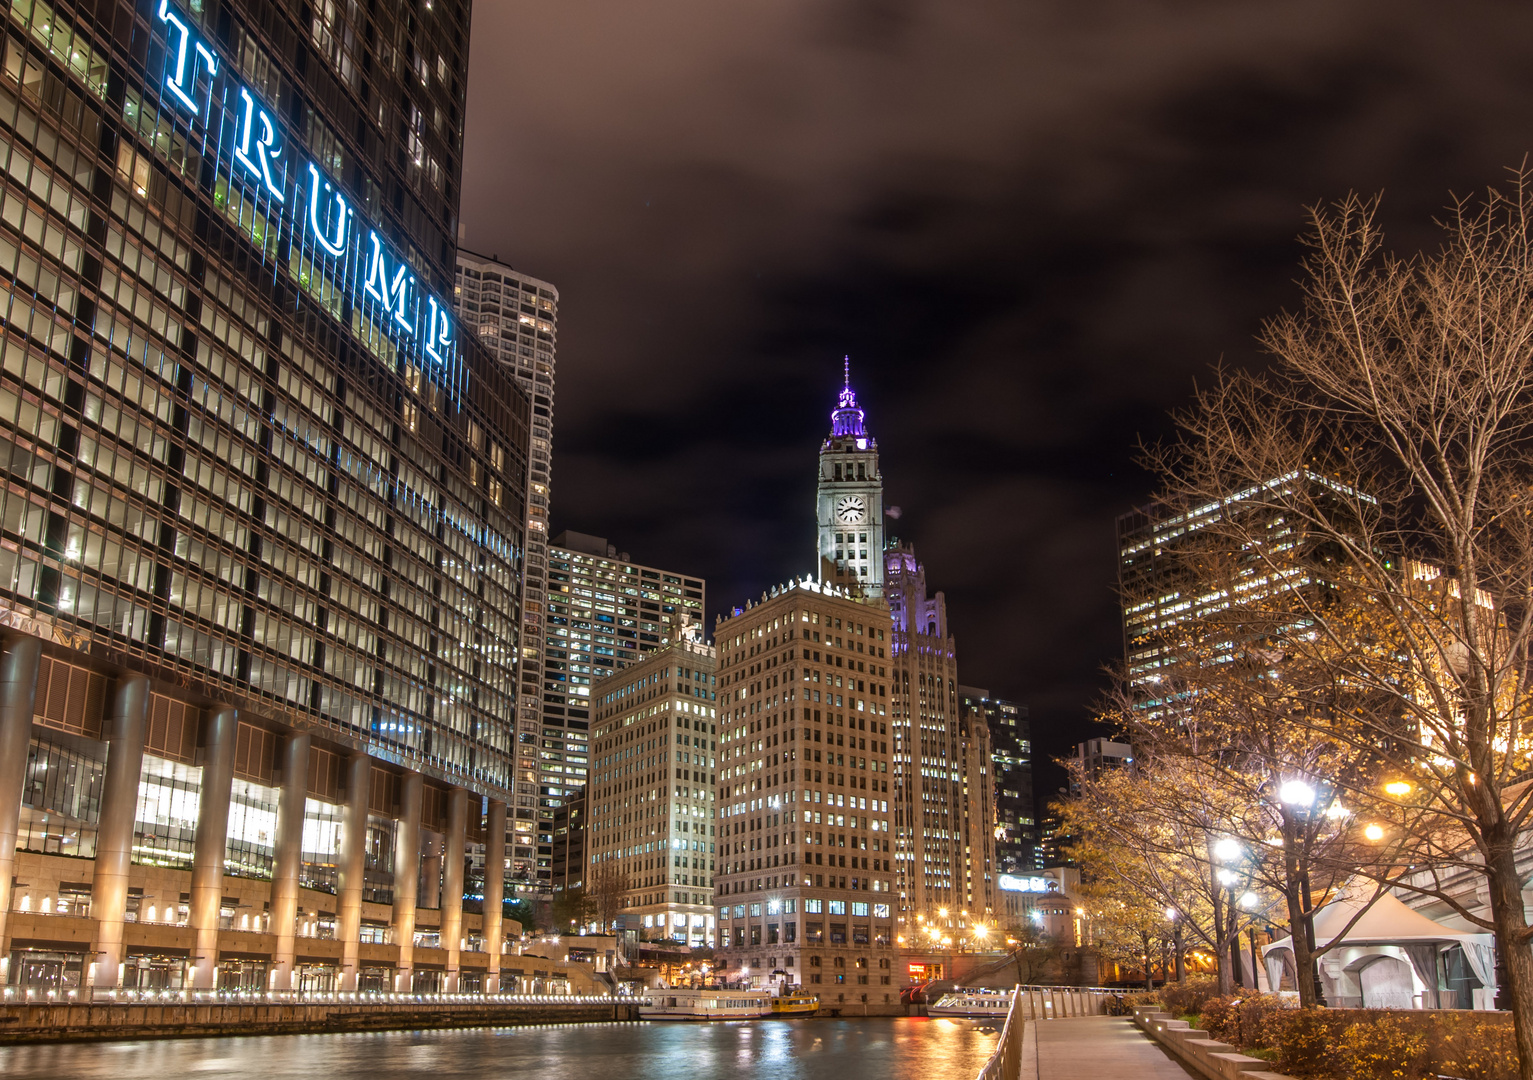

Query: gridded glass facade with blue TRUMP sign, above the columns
[[0, 0, 527, 787]]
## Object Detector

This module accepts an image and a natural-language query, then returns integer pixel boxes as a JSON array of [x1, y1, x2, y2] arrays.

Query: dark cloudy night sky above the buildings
[[463, 0, 1533, 792]]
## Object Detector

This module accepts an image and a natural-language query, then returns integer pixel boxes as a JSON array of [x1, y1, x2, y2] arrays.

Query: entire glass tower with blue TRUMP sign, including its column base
[[0, 0, 529, 993]]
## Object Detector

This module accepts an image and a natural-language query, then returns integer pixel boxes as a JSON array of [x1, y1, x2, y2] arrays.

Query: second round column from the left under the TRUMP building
[[90, 676, 149, 990]]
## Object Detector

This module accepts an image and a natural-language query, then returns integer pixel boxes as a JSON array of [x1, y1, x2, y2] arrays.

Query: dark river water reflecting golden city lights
[[0, 1017, 996, 1080]]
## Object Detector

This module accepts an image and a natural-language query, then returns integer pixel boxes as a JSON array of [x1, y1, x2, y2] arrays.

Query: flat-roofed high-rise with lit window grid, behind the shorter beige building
[[533, 530, 707, 892]]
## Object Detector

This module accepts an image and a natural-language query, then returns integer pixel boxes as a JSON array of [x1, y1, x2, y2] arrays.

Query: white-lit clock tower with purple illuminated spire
[[816, 358, 883, 596]]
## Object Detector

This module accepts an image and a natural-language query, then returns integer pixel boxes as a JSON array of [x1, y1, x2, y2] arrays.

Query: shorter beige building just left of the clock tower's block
[[586, 640, 719, 945]]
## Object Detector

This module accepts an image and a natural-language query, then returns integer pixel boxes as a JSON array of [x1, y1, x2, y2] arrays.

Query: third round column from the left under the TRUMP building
[[190, 709, 239, 990]]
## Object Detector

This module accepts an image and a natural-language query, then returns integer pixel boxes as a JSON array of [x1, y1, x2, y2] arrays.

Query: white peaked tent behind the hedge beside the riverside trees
[[1262, 885, 1496, 1008]]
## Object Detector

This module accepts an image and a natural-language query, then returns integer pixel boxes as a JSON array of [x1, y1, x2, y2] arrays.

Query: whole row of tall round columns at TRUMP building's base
[[0, 631, 506, 993]]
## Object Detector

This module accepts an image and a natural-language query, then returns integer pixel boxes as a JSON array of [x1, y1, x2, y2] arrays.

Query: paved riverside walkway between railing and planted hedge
[[1021, 1016, 1196, 1080]]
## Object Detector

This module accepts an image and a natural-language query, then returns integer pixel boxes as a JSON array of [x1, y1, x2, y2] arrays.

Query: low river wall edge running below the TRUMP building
[[0, 1003, 638, 1046]]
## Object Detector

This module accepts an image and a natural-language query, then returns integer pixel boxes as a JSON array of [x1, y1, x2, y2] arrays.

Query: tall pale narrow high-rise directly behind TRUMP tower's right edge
[[454, 248, 560, 892]]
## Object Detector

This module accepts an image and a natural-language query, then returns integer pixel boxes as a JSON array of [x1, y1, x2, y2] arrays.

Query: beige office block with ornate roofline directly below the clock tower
[[714, 579, 898, 1006]]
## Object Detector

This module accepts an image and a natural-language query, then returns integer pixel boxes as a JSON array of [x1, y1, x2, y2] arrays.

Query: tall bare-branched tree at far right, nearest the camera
[[1153, 170, 1533, 1080]]
